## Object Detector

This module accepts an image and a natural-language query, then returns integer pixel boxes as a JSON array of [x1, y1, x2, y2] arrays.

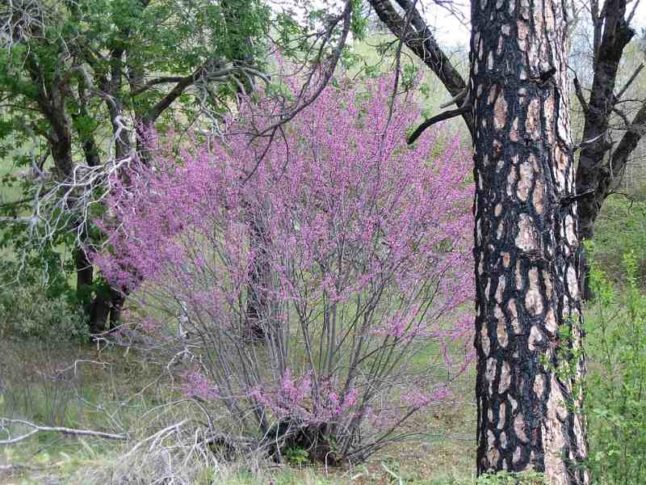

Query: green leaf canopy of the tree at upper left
[[0, 0, 271, 328]]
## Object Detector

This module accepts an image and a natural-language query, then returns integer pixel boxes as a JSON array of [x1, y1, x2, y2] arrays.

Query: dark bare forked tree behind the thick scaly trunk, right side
[[574, 0, 646, 296]]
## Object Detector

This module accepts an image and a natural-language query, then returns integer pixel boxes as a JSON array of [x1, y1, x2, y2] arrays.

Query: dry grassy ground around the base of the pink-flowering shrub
[[0, 340, 475, 484]]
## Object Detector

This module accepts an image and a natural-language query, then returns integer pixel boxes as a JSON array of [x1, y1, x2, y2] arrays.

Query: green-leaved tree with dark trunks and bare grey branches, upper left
[[0, 0, 269, 332]]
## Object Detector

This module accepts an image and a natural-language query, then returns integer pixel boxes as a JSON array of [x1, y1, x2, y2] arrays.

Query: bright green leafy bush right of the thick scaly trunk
[[586, 246, 646, 484]]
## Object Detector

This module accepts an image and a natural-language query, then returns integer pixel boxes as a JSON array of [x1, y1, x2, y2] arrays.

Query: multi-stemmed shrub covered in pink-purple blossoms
[[96, 75, 473, 461]]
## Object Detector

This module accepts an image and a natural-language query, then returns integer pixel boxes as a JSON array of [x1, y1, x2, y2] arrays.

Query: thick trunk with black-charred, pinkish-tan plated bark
[[470, 0, 588, 484]]
